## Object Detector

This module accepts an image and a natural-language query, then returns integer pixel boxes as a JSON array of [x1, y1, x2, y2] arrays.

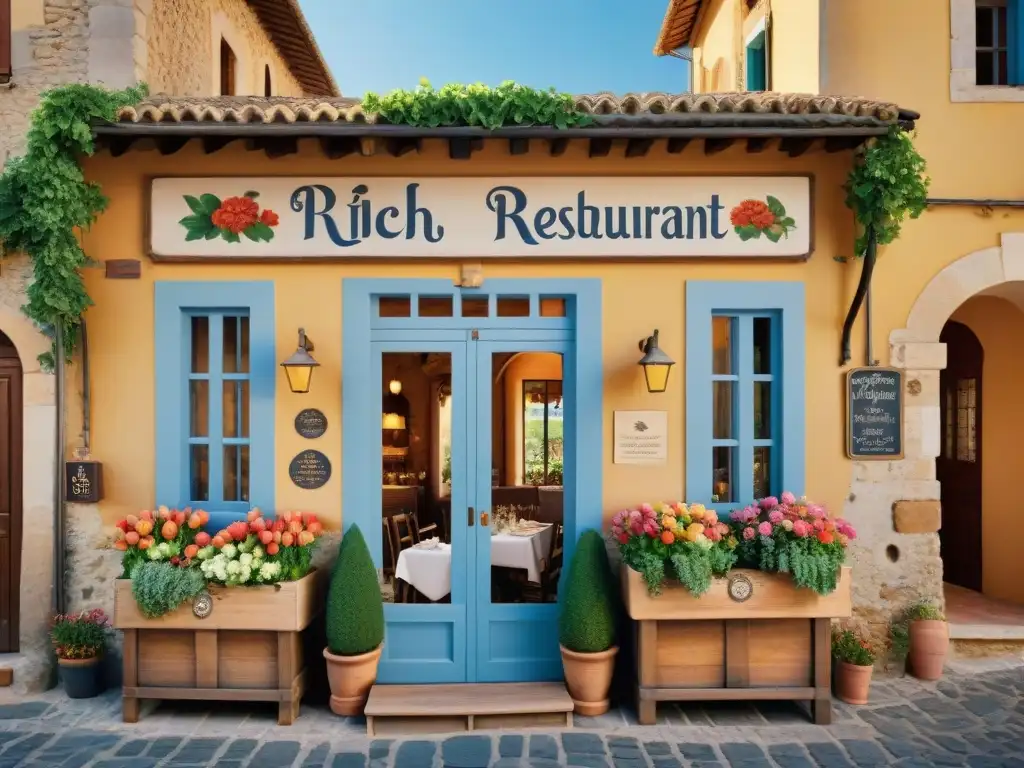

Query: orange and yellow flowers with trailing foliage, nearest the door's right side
[[611, 503, 737, 596]]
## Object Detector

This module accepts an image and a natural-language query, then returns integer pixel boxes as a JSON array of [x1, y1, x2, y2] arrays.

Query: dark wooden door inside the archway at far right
[[936, 322, 984, 592]]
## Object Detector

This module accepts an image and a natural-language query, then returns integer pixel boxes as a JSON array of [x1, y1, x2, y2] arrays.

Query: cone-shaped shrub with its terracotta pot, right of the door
[[559, 530, 618, 716]]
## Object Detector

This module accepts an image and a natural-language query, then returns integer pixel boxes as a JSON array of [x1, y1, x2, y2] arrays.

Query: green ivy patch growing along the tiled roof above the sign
[[362, 78, 593, 130]]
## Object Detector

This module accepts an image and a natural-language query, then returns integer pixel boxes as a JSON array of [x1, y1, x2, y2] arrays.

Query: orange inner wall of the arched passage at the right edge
[[944, 296, 1024, 603]]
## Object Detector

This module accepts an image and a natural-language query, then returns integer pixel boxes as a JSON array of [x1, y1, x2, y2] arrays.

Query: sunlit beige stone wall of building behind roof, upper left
[[147, 0, 302, 96]]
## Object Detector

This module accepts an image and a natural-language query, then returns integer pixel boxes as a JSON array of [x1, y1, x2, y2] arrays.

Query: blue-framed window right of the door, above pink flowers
[[686, 281, 805, 510]]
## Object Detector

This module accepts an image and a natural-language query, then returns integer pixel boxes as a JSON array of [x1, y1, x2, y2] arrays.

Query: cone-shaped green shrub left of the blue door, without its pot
[[327, 525, 384, 656]]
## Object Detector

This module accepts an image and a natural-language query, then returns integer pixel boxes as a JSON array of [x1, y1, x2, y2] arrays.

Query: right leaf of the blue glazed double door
[[473, 341, 567, 682]]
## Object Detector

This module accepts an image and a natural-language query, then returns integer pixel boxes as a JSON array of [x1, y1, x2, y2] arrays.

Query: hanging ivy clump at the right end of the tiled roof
[[846, 127, 931, 257]]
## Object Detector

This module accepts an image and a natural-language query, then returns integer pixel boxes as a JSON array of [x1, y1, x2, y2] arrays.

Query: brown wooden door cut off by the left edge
[[0, 346, 22, 653]]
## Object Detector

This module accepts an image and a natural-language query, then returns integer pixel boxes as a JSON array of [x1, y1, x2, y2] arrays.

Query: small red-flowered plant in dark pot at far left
[[50, 608, 110, 698]]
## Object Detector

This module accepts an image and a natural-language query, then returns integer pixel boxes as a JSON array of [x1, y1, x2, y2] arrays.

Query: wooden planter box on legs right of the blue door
[[622, 566, 851, 725]]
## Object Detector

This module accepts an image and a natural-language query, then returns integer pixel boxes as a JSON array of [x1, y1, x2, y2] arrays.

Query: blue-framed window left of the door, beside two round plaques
[[156, 283, 276, 526]]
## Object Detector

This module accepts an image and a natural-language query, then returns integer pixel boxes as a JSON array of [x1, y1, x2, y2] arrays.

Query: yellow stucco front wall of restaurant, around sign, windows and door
[[69, 141, 854, 527]]
